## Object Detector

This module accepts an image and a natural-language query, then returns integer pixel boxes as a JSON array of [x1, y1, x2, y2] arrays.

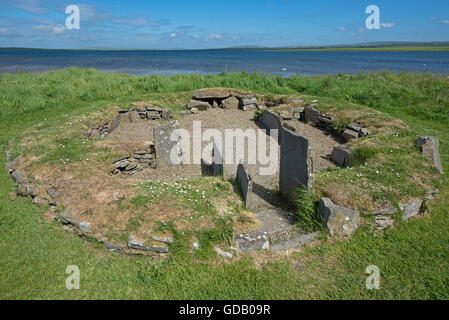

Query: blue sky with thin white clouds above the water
[[0, 0, 449, 49]]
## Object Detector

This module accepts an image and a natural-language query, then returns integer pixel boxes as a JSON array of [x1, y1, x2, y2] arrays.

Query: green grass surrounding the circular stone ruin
[[0, 68, 449, 299]]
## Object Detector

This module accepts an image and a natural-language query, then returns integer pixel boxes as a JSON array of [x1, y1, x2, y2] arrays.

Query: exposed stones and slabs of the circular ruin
[[7, 90, 443, 254]]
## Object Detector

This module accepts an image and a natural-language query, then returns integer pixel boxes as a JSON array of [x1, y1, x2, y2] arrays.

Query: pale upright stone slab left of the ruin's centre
[[153, 121, 181, 168]]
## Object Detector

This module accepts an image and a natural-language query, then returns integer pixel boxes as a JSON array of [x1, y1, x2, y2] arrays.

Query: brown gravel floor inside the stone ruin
[[109, 109, 340, 210]]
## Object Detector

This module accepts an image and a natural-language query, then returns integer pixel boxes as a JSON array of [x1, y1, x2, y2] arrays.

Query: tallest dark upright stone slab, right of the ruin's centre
[[279, 128, 313, 200]]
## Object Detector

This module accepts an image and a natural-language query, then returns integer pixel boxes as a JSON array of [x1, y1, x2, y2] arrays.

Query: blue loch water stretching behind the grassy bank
[[0, 49, 449, 76]]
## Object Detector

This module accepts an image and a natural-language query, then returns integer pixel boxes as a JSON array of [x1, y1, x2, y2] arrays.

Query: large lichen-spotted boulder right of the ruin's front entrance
[[319, 198, 360, 237]]
